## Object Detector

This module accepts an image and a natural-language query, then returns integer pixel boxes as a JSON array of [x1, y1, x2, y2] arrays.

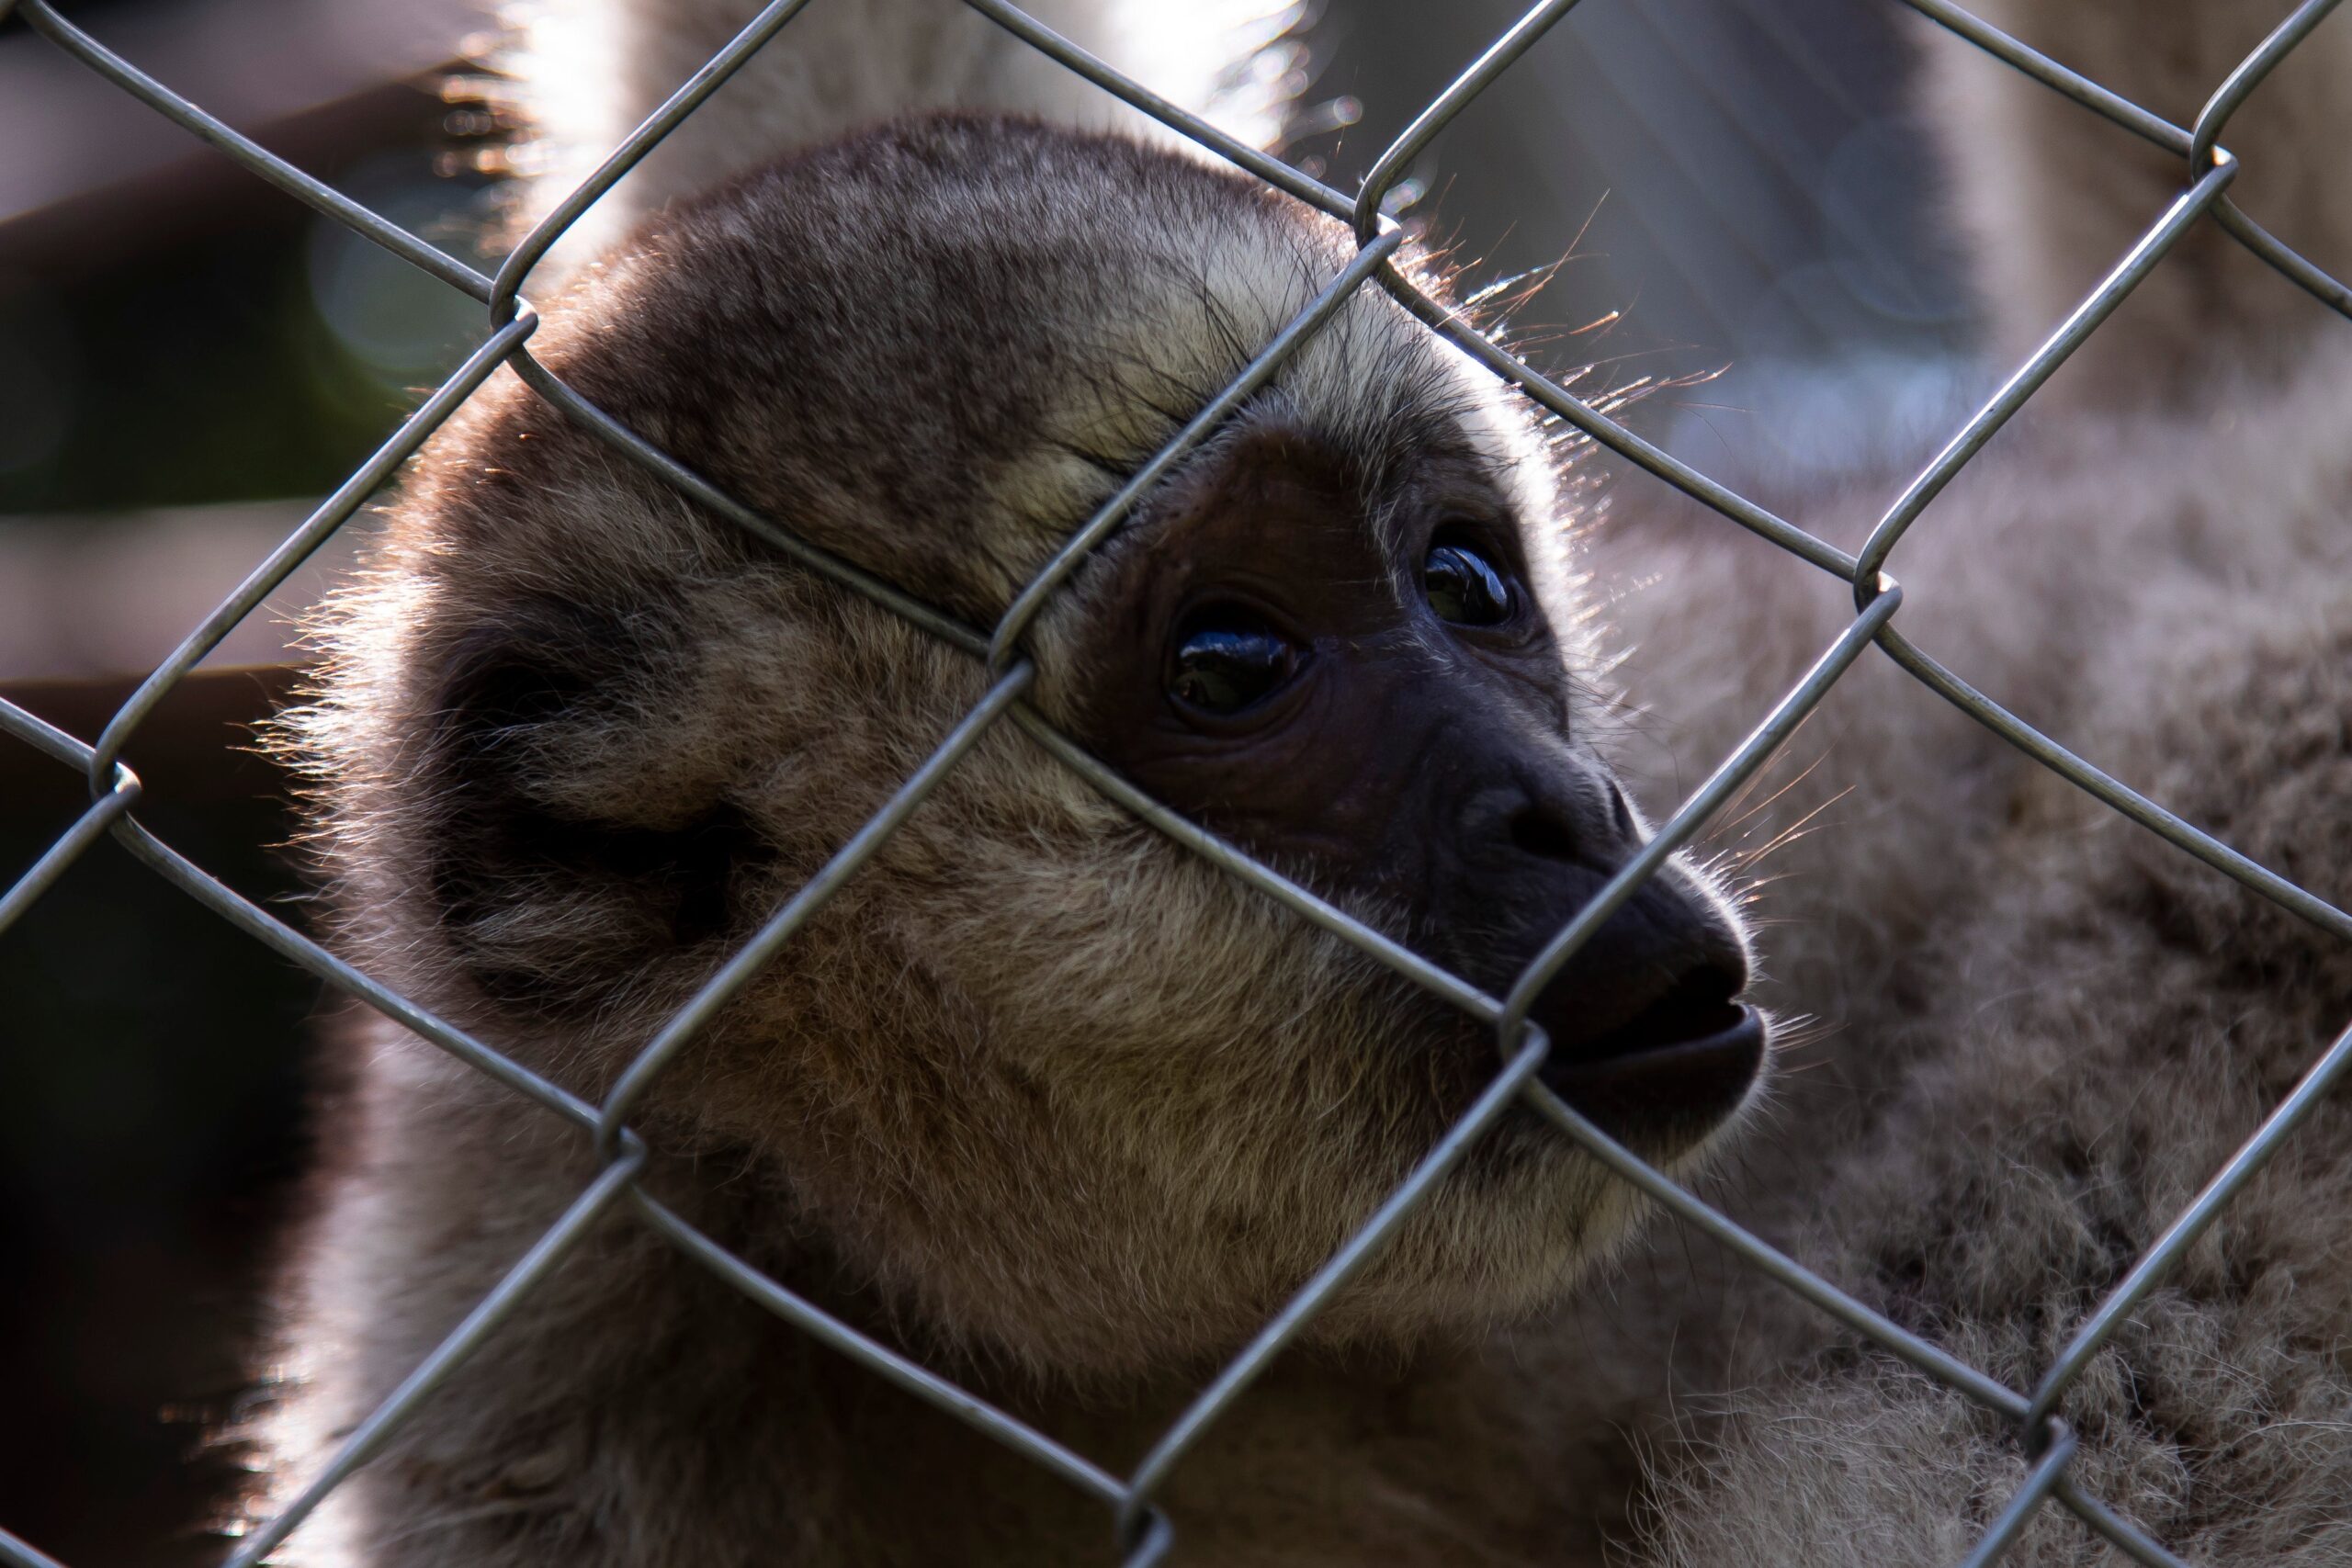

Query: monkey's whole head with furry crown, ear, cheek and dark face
[[287, 118, 1764, 1375]]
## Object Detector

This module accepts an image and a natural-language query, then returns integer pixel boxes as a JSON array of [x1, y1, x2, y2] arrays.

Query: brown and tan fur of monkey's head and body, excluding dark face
[[268, 5, 2352, 1565]]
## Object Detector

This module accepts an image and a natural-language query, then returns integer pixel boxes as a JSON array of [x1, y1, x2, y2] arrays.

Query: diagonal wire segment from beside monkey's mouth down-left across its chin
[[1120, 1025, 1553, 1544]]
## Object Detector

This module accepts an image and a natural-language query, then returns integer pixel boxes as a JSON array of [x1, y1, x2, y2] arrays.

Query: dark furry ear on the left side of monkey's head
[[416, 600, 769, 1013]]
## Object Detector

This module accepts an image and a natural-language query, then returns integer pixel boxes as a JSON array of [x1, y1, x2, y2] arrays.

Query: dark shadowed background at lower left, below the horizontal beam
[[0, 672, 320, 1568]]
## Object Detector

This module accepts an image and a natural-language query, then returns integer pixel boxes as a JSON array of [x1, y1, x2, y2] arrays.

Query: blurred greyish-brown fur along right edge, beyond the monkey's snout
[[1633, 3, 2352, 1568]]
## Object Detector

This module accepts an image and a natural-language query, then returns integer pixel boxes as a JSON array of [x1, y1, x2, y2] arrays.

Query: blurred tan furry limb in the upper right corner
[[1924, 0, 2352, 412]]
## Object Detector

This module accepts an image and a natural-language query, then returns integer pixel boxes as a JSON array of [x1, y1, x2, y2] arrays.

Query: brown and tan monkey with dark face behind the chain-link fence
[[254, 7, 2343, 1565]]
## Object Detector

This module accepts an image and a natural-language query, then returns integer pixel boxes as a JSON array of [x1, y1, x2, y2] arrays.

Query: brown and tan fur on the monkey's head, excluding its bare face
[[289, 118, 1758, 1373]]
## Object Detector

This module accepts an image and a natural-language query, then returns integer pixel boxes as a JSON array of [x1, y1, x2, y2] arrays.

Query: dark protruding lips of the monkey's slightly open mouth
[[1536, 968, 1767, 1134]]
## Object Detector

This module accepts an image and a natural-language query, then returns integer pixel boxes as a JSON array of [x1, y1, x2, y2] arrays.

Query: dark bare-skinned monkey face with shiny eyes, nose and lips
[[1087, 434, 1764, 1156]]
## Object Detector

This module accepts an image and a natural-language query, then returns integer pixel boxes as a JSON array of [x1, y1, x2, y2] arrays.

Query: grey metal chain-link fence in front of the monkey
[[0, 0, 2352, 1568]]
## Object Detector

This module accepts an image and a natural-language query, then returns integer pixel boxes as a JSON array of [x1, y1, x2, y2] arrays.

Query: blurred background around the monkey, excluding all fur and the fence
[[0, 0, 1985, 1568]]
